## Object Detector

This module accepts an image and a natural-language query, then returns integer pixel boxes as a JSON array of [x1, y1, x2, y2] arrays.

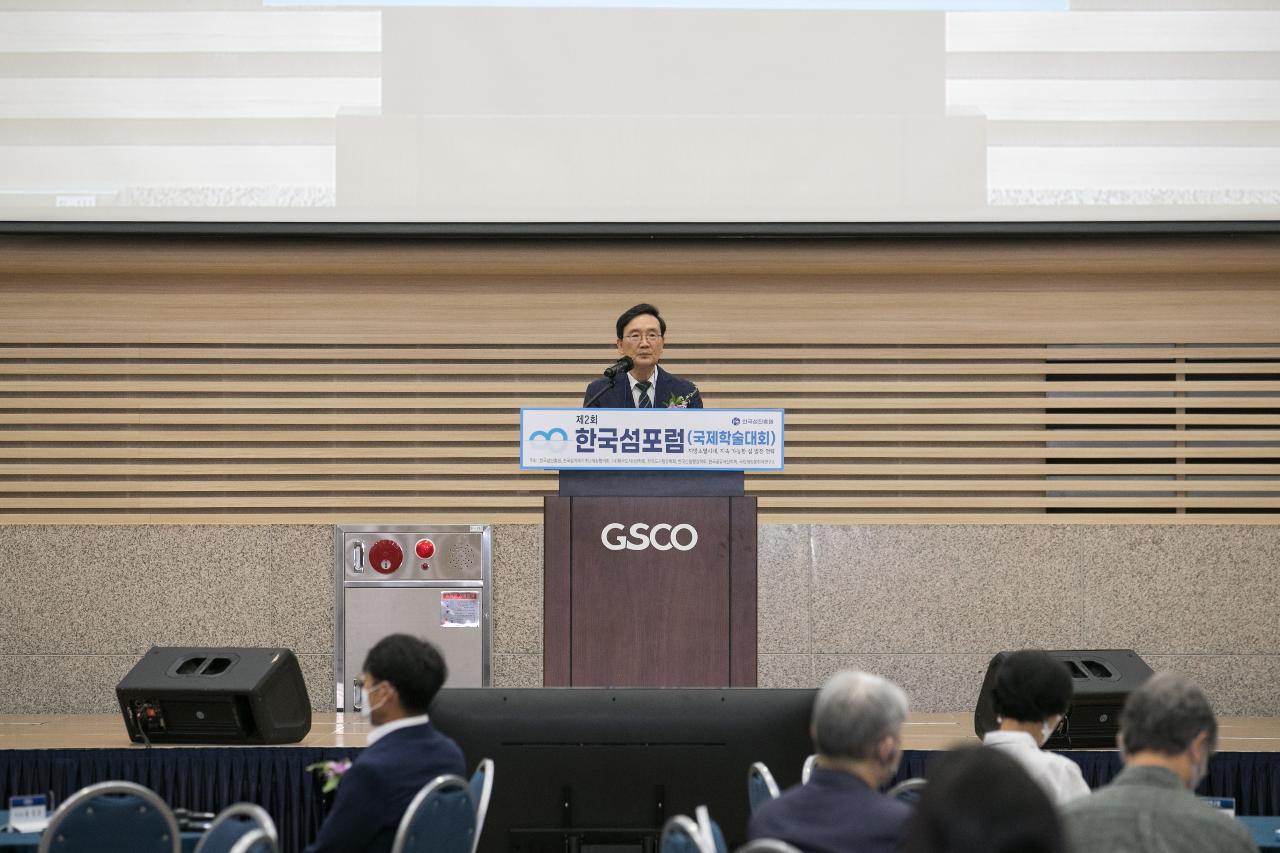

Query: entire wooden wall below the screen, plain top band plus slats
[[0, 237, 1280, 524]]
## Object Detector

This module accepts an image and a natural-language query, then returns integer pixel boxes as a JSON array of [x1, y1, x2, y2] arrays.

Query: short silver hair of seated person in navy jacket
[[813, 670, 908, 761]]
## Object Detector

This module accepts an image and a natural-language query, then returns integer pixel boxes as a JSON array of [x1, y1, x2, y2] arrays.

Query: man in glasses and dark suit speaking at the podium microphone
[[582, 302, 703, 409]]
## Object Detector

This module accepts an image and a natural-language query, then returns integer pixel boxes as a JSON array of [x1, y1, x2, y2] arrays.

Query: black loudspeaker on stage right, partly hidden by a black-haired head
[[973, 648, 1152, 749]]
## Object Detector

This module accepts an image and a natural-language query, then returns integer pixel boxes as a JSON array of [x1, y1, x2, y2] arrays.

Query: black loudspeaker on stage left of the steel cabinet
[[115, 646, 311, 743]]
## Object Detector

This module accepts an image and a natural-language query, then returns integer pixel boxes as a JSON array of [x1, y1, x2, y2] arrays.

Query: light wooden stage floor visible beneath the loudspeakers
[[0, 713, 1280, 752]]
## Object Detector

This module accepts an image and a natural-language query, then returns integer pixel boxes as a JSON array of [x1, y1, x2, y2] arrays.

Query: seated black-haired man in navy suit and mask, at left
[[307, 634, 466, 853]]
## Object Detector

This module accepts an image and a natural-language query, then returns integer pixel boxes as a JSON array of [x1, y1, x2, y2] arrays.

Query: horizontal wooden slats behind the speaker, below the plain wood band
[[0, 343, 1280, 523]]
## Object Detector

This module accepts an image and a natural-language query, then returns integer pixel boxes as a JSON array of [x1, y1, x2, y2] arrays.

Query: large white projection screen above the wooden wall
[[0, 0, 1280, 223]]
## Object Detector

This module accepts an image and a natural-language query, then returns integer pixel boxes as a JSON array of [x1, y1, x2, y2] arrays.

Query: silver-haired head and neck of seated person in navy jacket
[[812, 670, 908, 788]]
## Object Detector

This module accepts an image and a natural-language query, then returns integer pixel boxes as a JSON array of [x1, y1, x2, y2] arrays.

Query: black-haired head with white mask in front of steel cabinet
[[364, 634, 449, 725]]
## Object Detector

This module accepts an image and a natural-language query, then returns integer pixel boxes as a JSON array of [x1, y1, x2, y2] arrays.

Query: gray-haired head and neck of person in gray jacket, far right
[[1119, 672, 1217, 788]]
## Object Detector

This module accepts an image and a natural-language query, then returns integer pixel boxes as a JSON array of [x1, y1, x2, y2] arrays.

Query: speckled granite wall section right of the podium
[[759, 525, 1280, 716]]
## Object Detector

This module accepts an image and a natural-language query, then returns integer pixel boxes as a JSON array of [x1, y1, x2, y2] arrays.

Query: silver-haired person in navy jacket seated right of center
[[748, 670, 910, 853]]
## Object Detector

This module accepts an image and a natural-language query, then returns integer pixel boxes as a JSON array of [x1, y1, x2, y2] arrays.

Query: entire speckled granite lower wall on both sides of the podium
[[0, 525, 1280, 716]]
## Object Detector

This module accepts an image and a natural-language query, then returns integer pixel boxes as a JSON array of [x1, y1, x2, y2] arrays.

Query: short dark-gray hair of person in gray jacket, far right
[[1120, 672, 1217, 756]]
